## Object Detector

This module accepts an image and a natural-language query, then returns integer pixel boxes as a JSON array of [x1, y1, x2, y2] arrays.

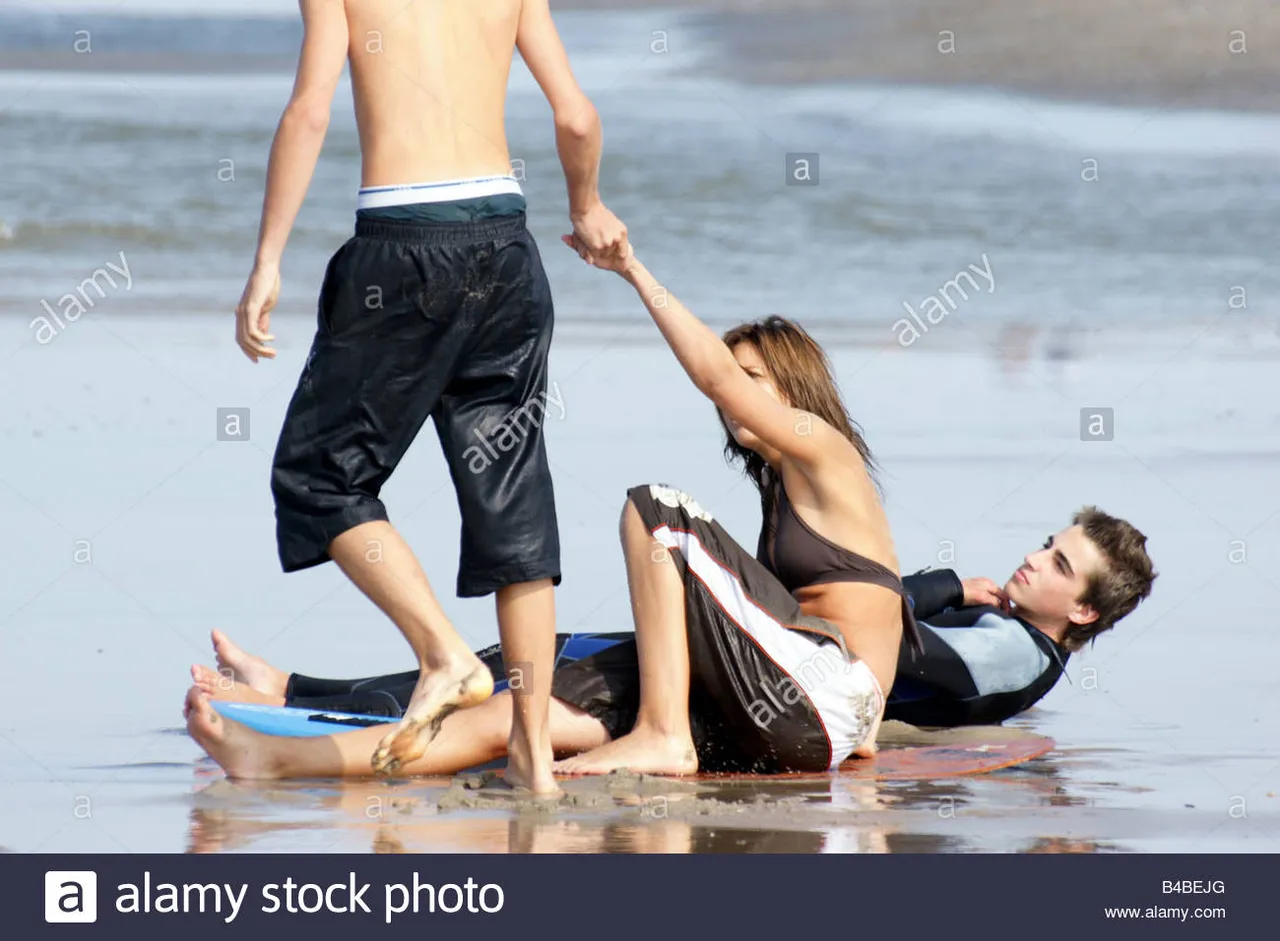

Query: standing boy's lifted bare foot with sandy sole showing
[[371, 650, 493, 775]]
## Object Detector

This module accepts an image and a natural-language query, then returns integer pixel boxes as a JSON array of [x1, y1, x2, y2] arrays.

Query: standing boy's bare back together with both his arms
[[236, 0, 630, 362]]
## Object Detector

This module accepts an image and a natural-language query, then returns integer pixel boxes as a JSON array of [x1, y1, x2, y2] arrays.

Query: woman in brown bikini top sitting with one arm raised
[[187, 237, 920, 777]]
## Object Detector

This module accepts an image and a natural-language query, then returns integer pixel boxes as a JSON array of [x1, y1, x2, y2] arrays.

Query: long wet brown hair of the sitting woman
[[719, 316, 879, 494]]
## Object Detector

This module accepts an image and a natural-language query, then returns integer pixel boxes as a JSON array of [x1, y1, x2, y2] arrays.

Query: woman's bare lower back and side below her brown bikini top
[[795, 581, 902, 695]]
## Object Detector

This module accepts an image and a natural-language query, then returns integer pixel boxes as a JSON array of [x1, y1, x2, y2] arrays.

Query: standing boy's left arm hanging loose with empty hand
[[236, 0, 347, 362]]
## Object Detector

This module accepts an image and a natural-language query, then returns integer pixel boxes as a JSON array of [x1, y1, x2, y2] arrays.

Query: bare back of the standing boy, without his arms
[[347, 0, 521, 187]]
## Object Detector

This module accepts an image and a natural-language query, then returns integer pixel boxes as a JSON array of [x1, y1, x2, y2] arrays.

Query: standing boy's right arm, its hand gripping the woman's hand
[[516, 0, 627, 255]]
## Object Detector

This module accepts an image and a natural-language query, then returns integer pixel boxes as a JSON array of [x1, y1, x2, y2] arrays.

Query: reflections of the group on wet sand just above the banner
[[188, 742, 1090, 854]]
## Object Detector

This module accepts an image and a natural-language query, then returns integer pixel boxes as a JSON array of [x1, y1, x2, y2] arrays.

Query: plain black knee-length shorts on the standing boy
[[271, 213, 561, 597]]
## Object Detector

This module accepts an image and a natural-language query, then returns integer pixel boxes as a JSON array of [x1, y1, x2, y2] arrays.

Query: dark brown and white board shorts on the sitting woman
[[552, 485, 884, 773]]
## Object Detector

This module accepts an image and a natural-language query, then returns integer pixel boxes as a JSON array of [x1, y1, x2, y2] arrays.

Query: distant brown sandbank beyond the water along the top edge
[[10, 0, 1280, 111]]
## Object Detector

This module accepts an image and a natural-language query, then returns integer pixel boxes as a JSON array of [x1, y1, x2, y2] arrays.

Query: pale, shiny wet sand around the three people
[[0, 314, 1280, 853]]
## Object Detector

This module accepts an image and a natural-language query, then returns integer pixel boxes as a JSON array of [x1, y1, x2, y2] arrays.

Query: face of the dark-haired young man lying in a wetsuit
[[1005, 526, 1106, 623]]
